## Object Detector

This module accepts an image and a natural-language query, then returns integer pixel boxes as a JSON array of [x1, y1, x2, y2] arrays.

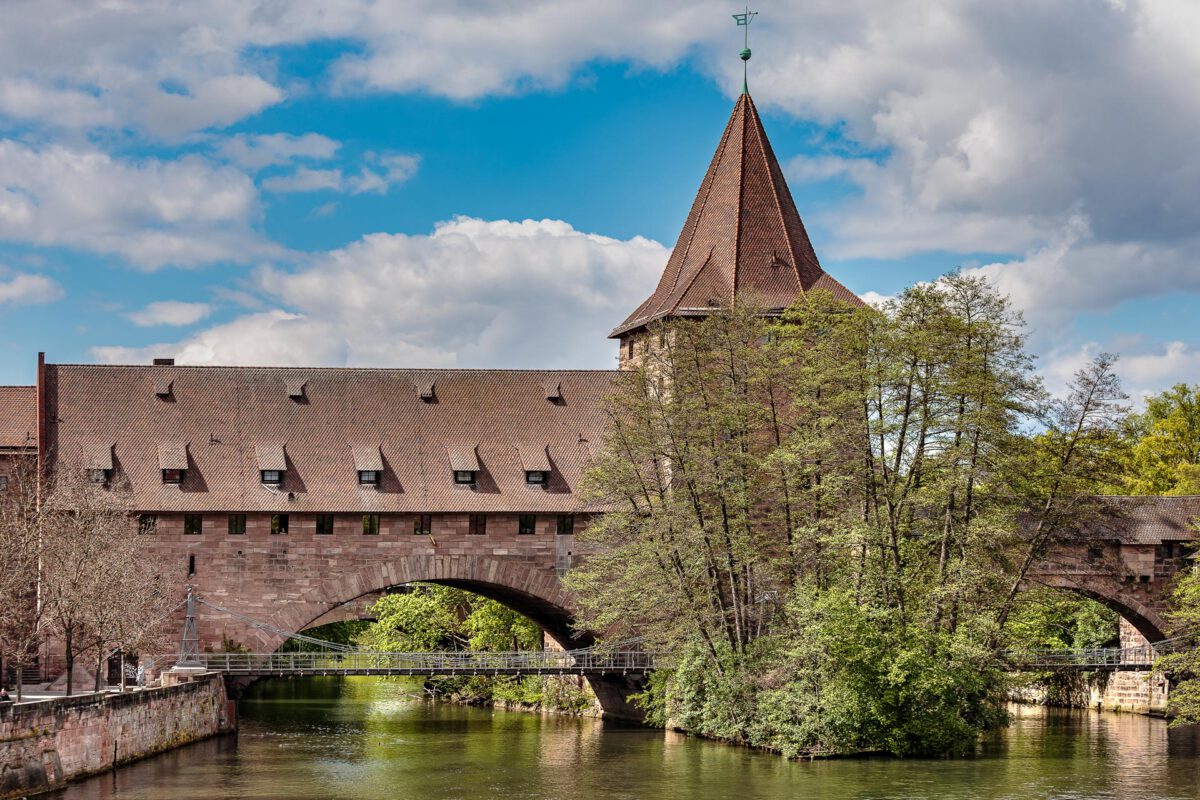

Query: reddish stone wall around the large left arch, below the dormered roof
[[137, 512, 587, 651]]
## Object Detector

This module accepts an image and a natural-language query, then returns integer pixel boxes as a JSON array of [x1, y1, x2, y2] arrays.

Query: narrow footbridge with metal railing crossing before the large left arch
[[164, 649, 654, 676]]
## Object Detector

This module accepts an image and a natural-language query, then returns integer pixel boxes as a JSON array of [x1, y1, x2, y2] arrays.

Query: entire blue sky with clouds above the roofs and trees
[[0, 0, 1200, 397]]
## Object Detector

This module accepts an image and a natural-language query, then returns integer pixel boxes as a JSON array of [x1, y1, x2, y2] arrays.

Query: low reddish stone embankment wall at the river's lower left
[[0, 674, 235, 800]]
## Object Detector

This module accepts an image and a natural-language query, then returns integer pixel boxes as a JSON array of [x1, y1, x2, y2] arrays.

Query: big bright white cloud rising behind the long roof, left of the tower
[[92, 217, 668, 368]]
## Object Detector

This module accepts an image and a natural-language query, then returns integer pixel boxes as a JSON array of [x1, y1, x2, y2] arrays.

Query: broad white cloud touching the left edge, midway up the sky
[[0, 139, 281, 269]]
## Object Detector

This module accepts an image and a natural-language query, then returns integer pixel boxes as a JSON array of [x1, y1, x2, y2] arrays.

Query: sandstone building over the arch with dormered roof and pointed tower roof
[[0, 95, 858, 681]]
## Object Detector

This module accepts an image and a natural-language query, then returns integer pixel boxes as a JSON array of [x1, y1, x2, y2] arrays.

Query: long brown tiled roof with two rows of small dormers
[[46, 365, 617, 513]]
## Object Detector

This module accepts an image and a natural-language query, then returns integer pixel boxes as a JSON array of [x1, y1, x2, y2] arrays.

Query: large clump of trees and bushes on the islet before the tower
[[568, 275, 1124, 754]]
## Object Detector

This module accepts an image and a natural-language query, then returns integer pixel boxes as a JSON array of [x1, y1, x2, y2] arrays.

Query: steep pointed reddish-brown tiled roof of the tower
[[610, 94, 862, 338]]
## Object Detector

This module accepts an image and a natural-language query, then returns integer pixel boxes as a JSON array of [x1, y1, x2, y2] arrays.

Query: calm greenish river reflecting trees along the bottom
[[56, 678, 1200, 800]]
